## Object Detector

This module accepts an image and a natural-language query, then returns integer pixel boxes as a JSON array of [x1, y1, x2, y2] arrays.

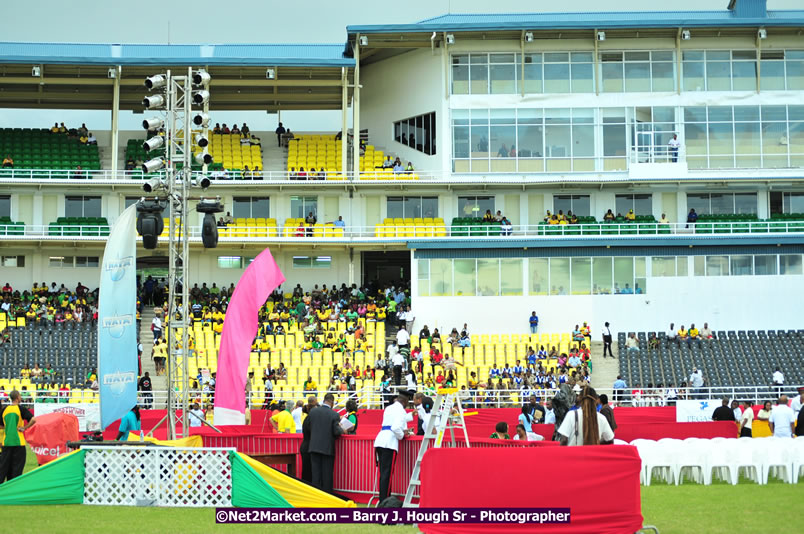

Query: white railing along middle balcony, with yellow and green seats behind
[[0, 221, 804, 243]]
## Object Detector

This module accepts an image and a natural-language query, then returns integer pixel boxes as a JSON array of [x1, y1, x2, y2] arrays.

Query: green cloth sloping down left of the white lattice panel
[[0, 450, 85, 506]]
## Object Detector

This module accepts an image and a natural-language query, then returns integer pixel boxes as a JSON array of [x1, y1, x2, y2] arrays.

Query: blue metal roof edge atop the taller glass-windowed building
[[346, 10, 804, 34]]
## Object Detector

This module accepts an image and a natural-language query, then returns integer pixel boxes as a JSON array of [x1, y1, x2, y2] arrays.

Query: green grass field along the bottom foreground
[[9, 452, 804, 534]]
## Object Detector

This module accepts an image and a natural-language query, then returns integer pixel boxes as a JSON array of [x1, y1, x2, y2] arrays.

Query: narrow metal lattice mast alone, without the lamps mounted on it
[[165, 68, 193, 439]]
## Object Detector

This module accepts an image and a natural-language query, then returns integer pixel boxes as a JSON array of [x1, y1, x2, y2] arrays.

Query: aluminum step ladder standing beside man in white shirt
[[402, 388, 469, 508]]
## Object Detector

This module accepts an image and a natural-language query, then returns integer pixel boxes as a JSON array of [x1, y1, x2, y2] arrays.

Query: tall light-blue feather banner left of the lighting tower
[[98, 204, 137, 429]]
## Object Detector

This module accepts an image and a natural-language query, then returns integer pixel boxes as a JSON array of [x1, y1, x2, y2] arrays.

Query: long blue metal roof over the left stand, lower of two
[[0, 42, 355, 67]]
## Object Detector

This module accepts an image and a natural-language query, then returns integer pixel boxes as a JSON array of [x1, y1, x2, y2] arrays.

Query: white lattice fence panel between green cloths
[[84, 446, 233, 507]]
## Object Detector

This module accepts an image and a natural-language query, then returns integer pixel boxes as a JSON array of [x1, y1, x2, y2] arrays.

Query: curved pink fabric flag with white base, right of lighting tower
[[215, 248, 285, 426]]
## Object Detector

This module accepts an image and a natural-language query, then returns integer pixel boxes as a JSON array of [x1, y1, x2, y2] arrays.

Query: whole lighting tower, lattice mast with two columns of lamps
[[143, 67, 217, 439]]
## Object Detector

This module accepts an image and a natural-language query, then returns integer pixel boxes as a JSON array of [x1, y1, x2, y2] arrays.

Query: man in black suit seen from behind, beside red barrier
[[307, 393, 343, 493]]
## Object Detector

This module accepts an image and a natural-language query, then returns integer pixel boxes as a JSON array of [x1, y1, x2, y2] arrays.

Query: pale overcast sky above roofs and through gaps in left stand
[[0, 0, 804, 131]]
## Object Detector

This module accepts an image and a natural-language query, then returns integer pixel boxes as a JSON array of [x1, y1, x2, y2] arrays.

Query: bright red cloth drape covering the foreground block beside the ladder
[[419, 445, 642, 534]]
